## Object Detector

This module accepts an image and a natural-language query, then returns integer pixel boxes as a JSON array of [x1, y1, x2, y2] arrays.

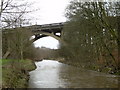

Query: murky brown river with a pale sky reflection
[[29, 60, 119, 88]]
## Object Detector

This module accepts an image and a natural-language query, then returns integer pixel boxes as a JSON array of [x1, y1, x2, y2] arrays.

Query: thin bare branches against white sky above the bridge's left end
[[0, 0, 31, 28]]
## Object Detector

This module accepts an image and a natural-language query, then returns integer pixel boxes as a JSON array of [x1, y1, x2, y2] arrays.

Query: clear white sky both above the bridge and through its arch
[[29, 0, 70, 49]]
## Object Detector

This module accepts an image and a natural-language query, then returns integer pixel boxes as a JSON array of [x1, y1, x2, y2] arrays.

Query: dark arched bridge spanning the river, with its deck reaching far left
[[2, 22, 66, 58]]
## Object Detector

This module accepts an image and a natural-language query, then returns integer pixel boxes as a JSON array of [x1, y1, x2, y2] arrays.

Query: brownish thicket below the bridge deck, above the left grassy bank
[[2, 28, 34, 59]]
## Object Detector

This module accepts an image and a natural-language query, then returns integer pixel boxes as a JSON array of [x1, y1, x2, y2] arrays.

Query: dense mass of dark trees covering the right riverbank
[[59, 0, 120, 73]]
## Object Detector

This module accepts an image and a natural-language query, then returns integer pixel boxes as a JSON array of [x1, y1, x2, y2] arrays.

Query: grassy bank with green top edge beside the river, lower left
[[2, 59, 36, 88]]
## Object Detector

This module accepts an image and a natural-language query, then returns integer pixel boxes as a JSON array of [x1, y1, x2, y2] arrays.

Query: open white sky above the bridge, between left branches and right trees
[[31, 0, 70, 24]]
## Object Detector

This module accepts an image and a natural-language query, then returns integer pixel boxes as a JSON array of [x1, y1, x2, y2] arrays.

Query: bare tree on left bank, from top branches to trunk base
[[0, 0, 35, 59]]
